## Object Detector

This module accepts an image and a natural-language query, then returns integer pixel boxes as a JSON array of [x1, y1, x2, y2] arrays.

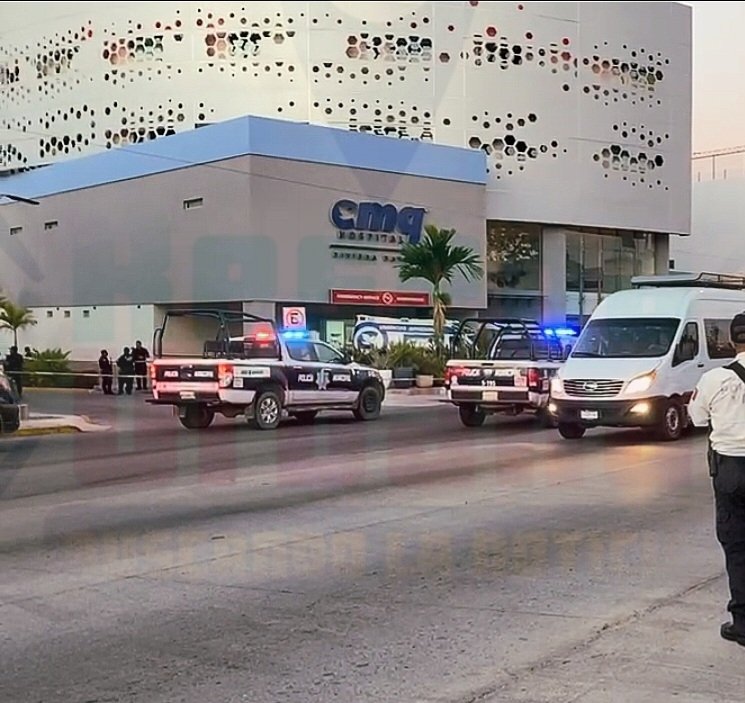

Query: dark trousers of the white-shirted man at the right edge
[[710, 454, 745, 633]]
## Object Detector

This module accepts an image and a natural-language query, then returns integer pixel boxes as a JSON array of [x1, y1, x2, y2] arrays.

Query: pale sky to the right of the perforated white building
[[683, 0, 745, 152]]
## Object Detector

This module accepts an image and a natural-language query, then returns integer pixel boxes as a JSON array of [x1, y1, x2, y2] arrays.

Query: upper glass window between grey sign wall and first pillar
[[486, 220, 541, 293]]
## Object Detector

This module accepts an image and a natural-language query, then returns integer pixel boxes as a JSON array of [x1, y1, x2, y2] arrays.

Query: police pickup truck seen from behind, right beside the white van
[[445, 318, 575, 427]]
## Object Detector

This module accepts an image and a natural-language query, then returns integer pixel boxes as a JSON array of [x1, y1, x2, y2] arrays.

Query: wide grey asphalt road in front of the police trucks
[[0, 393, 745, 703]]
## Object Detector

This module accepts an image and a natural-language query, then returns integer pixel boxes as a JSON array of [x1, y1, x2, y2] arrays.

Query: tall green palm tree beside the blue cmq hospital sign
[[397, 225, 484, 347]]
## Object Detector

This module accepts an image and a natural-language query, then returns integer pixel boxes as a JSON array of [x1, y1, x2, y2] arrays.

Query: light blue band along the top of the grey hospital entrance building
[[0, 116, 486, 198]]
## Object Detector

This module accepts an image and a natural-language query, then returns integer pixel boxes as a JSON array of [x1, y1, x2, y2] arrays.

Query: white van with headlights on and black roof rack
[[549, 273, 745, 441]]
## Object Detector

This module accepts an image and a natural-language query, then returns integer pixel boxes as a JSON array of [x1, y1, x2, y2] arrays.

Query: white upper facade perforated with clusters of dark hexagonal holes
[[0, 0, 691, 233]]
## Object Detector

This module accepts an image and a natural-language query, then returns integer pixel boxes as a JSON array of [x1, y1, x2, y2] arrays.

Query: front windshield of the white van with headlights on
[[571, 317, 680, 359]]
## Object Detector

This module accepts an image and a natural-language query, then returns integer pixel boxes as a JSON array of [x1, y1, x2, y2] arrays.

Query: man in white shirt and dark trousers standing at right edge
[[688, 312, 745, 647]]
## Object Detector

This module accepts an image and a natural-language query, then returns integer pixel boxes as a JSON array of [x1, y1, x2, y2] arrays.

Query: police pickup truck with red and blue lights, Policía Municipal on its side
[[147, 309, 385, 430]]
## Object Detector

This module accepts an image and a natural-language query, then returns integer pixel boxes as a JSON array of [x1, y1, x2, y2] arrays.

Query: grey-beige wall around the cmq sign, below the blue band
[[0, 157, 486, 314]]
